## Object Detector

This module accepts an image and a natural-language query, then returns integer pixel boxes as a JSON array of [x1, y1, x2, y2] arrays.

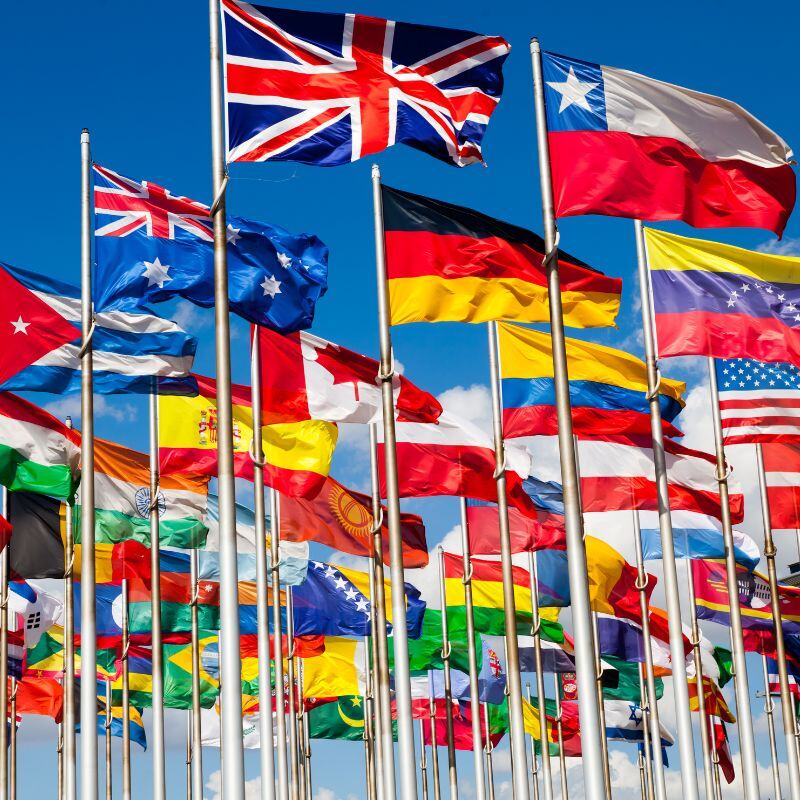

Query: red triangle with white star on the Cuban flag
[[0, 267, 81, 383]]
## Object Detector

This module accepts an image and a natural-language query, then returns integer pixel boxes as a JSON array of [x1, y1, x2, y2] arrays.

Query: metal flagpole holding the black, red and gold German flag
[[372, 164, 417, 800]]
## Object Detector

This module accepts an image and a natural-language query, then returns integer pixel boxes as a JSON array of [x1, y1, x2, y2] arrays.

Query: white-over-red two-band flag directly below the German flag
[[378, 413, 535, 515]]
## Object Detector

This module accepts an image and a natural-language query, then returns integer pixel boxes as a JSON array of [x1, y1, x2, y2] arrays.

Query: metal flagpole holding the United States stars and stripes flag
[[708, 356, 760, 800]]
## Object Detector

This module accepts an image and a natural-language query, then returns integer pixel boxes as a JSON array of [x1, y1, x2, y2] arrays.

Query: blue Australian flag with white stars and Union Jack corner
[[94, 165, 328, 333]]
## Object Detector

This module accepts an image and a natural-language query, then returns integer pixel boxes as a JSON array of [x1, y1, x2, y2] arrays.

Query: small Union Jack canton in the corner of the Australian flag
[[94, 164, 214, 242]]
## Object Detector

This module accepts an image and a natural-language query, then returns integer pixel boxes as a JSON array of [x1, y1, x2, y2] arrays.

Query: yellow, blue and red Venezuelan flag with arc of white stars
[[645, 228, 800, 364]]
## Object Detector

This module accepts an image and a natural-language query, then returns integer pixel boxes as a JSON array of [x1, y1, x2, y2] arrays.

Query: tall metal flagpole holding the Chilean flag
[[531, 39, 604, 800]]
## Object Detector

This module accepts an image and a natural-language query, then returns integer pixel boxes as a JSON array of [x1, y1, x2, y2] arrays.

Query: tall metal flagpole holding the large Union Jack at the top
[[208, 0, 244, 800]]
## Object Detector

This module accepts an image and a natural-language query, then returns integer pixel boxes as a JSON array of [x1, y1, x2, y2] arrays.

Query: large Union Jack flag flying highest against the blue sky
[[222, 0, 510, 166]]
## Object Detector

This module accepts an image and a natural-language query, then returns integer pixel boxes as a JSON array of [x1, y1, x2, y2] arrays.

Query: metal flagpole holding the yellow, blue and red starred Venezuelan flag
[[634, 220, 699, 800]]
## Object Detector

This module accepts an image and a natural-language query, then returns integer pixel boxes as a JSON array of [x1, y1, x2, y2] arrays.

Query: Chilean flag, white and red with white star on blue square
[[542, 53, 795, 235]]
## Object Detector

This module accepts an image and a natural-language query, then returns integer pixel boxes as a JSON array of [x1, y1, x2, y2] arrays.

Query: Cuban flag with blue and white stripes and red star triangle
[[0, 265, 197, 394]]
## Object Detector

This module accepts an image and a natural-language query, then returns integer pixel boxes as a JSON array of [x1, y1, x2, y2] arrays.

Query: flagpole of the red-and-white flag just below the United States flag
[[756, 444, 800, 800]]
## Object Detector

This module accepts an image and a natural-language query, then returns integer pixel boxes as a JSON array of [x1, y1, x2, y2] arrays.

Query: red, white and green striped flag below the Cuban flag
[[0, 392, 81, 498]]
